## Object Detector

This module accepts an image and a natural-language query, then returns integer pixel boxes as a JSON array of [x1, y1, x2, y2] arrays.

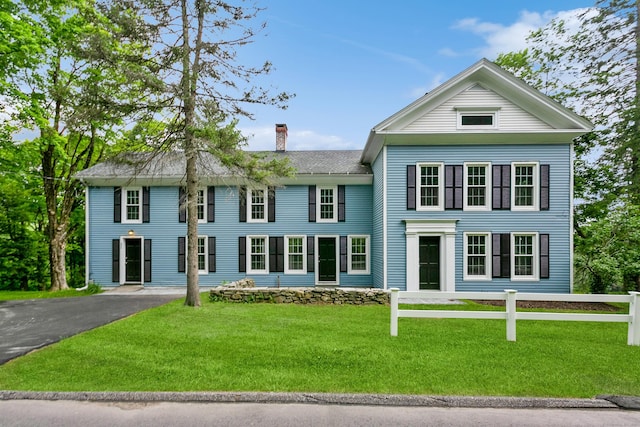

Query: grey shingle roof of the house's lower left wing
[[76, 150, 372, 181]]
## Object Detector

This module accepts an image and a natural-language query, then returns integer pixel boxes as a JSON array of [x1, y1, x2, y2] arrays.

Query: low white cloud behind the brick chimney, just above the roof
[[242, 126, 362, 151]]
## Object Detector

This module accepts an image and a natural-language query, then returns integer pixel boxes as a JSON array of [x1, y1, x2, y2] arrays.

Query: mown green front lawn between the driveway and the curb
[[0, 294, 640, 397]]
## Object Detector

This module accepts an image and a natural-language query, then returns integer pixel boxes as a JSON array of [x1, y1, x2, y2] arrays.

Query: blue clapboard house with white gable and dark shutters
[[77, 60, 592, 292]]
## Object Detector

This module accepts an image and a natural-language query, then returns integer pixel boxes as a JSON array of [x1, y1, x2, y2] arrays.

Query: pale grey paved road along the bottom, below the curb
[[0, 400, 640, 427]]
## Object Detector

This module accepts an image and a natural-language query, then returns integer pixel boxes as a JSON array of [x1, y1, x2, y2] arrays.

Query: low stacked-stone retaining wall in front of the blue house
[[209, 286, 389, 305]]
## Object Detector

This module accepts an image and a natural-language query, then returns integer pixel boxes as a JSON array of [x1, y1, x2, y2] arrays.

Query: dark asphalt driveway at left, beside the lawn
[[0, 294, 181, 365]]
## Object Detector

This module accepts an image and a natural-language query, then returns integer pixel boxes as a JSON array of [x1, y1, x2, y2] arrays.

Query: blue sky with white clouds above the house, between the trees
[[238, 0, 593, 150]]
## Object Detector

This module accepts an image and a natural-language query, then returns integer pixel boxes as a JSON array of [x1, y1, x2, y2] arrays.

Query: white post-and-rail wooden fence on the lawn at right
[[391, 288, 640, 345]]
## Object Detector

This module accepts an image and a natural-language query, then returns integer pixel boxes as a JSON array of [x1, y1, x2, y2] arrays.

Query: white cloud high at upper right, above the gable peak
[[448, 9, 584, 59]]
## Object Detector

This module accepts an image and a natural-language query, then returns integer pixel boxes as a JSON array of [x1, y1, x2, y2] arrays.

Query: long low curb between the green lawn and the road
[[0, 390, 640, 409]]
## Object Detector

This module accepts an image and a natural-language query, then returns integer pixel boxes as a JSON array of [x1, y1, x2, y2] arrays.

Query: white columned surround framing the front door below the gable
[[404, 219, 458, 292]]
